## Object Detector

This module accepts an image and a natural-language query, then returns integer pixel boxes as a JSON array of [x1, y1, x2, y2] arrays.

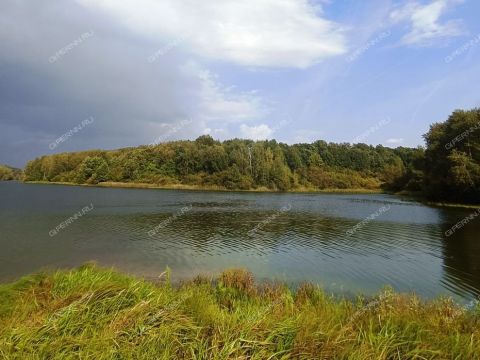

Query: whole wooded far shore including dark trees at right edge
[[24, 109, 480, 203]]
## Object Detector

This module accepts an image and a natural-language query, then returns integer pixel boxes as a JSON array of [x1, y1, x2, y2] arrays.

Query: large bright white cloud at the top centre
[[77, 0, 346, 68]]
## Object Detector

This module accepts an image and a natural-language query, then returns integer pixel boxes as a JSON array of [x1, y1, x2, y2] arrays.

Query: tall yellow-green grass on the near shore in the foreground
[[0, 264, 480, 360]]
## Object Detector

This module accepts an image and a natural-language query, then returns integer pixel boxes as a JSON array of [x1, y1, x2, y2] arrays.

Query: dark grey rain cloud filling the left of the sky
[[0, 0, 201, 166]]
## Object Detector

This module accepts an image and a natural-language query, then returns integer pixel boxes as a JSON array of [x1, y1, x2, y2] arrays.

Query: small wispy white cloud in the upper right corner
[[390, 0, 464, 46]]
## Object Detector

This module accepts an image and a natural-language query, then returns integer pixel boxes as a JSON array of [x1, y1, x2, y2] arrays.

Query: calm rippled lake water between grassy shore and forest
[[0, 182, 480, 301]]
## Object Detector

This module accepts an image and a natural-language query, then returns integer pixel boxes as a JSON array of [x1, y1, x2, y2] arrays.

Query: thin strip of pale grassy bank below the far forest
[[25, 181, 384, 194]]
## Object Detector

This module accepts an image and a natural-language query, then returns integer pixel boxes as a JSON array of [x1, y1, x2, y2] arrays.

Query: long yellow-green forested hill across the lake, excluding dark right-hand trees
[[25, 136, 422, 191]]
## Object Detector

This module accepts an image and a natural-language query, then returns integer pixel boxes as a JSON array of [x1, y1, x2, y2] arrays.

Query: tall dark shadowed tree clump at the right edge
[[425, 109, 480, 203]]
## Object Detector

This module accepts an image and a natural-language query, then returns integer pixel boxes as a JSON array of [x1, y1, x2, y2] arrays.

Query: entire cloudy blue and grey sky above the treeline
[[0, 0, 480, 167]]
